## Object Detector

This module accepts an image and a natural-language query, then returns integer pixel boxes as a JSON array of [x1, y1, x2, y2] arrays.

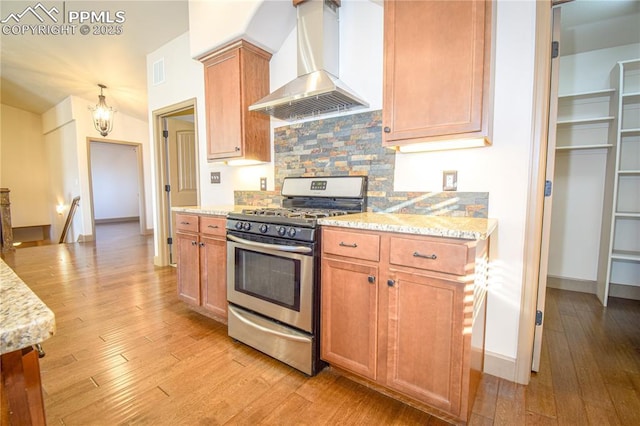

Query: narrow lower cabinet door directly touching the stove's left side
[[200, 237, 227, 318]]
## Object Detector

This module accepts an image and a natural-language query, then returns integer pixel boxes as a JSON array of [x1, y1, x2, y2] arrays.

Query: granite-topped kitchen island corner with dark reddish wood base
[[0, 259, 56, 425]]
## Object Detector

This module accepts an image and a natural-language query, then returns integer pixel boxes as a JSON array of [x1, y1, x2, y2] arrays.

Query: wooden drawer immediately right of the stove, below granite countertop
[[322, 229, 380, 262]]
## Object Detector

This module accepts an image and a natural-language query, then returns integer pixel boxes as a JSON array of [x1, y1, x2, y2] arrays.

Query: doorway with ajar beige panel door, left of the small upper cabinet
[[153, 99, 200, 266]]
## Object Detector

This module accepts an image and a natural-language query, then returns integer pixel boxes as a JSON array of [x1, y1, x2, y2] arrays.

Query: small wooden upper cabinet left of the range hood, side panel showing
[[200, 40, 271, 162]]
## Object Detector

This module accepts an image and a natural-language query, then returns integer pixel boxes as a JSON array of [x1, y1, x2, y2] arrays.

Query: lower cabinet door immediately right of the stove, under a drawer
[[320, 259, 378, 380]]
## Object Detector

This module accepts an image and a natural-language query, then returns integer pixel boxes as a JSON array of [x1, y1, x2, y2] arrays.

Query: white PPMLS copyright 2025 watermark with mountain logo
[[0, 2, 126, 36]]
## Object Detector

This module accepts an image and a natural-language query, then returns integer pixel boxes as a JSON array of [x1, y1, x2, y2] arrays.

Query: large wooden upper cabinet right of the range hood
[[382, 0, 492, 146]]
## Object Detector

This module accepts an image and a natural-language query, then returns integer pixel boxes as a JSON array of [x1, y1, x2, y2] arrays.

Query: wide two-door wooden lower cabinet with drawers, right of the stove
[[321, 227, 487, 423]]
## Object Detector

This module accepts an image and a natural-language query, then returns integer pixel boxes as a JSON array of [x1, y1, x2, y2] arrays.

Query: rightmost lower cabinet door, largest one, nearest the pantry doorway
[[386, 273, 465, 414]]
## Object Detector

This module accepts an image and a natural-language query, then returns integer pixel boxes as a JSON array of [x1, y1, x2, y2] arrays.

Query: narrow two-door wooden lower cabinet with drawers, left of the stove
[[176, 214, 227, 320]]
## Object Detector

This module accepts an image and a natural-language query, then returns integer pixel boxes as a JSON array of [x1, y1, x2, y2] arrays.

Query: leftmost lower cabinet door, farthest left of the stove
[[176, 233, 200, 306]]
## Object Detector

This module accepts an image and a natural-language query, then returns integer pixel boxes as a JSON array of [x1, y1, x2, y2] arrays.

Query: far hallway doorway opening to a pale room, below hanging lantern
[[87, 138, 146, 240]]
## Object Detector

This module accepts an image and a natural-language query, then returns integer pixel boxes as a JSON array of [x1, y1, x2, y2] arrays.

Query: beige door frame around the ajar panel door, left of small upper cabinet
[[152, 98, 200, 266]]
